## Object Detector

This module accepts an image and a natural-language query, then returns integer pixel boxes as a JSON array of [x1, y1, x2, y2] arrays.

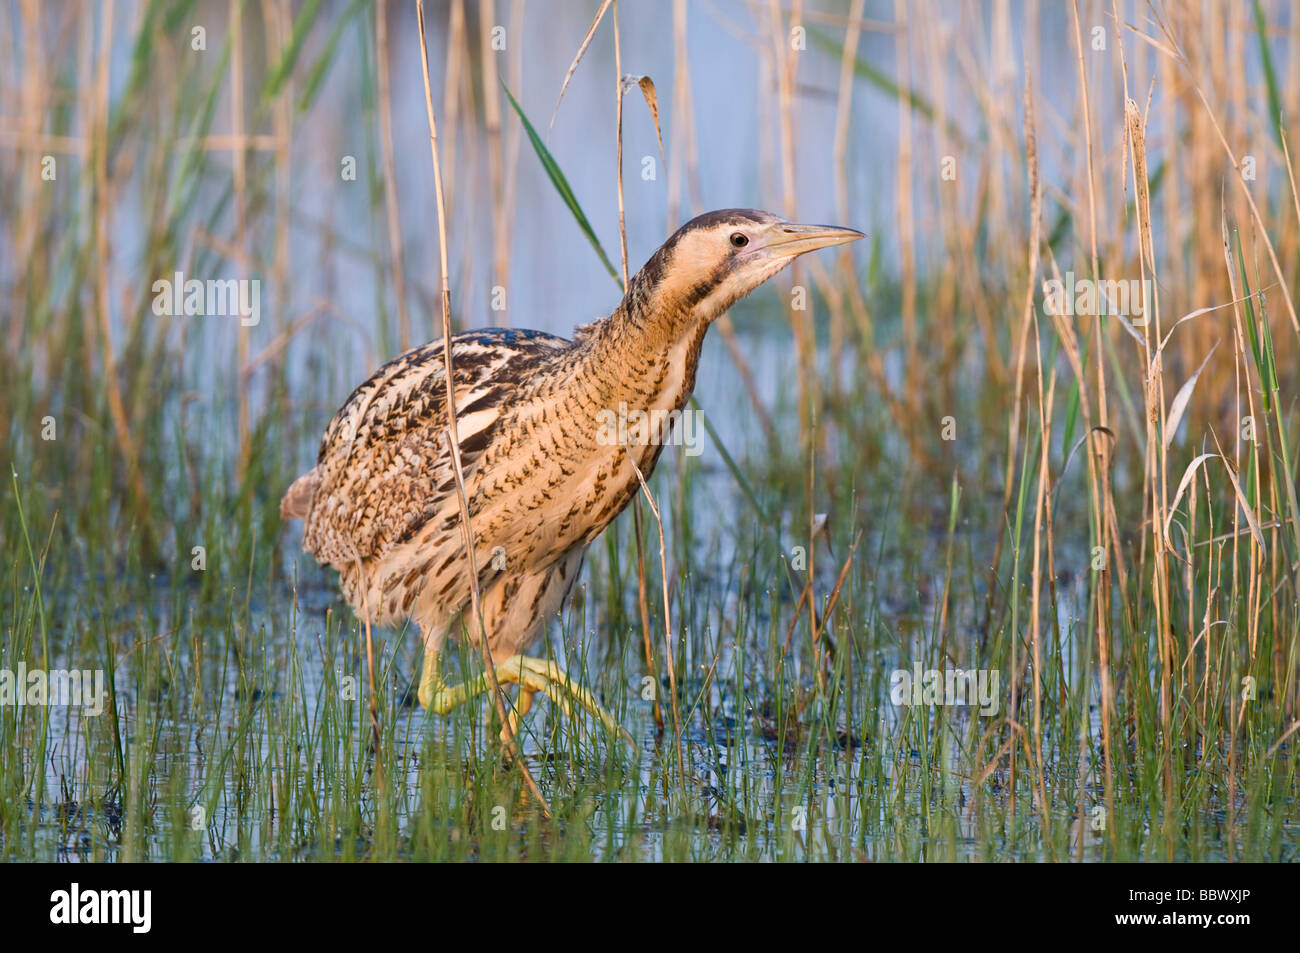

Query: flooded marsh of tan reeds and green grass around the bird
[[0, 0, 1300, 861]]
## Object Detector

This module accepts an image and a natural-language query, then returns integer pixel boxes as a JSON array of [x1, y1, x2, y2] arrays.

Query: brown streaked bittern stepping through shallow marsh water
[[281, 209, 863, 733]]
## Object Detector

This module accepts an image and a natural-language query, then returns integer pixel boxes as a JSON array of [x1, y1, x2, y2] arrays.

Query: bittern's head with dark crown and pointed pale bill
[[628, 208, 863, 321]]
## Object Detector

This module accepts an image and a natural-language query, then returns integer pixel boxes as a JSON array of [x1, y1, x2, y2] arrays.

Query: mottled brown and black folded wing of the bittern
[[303, 329, 569, 568]]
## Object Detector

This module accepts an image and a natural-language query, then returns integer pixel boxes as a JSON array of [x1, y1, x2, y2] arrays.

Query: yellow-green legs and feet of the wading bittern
[[420, 651, 631, 740]]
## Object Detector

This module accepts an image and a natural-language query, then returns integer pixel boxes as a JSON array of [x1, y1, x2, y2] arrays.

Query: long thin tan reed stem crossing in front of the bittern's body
[[416, 0, 551, 818]]
